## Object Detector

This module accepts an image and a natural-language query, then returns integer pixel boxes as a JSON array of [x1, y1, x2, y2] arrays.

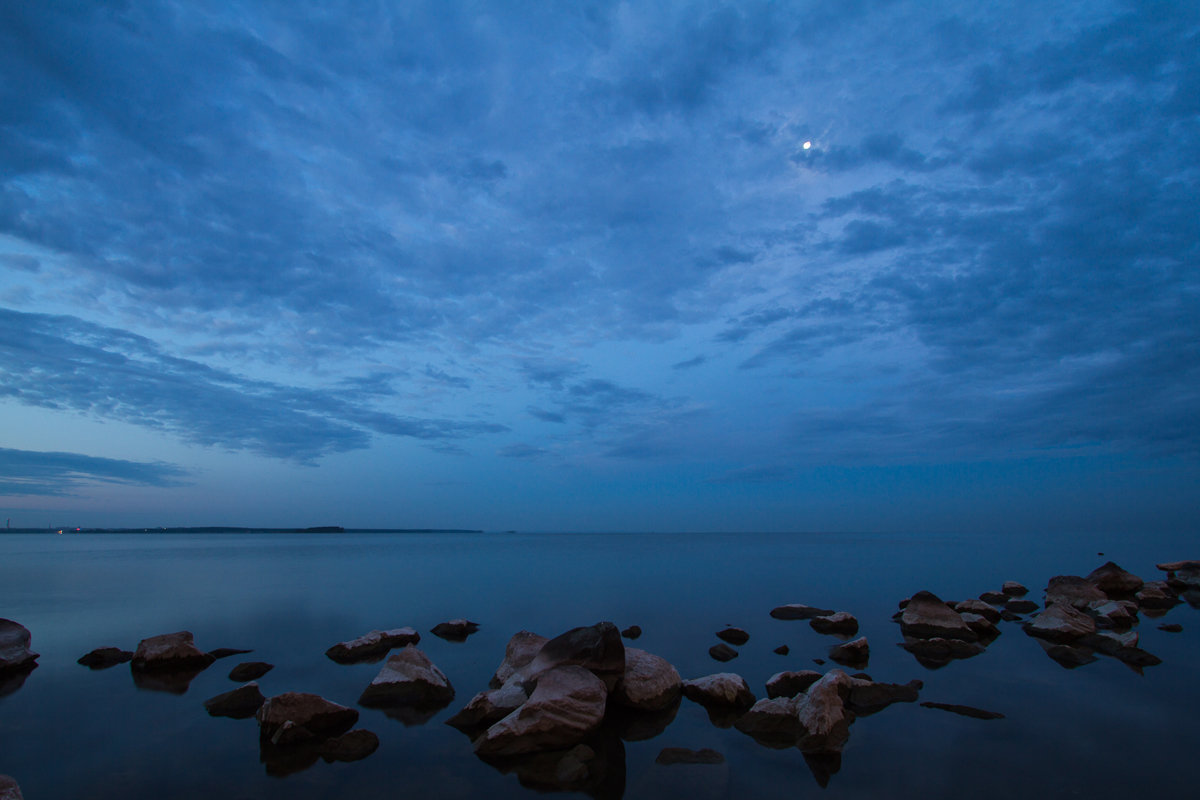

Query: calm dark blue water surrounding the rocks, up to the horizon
[[0, 531, 1200, 800]]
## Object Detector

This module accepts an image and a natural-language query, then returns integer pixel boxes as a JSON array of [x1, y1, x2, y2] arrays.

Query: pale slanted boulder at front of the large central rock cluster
[[474, 662, 617, 757]]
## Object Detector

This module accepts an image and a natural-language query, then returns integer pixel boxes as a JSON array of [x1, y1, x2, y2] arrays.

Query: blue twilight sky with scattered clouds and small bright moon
[[0, 0, 1200, 535]]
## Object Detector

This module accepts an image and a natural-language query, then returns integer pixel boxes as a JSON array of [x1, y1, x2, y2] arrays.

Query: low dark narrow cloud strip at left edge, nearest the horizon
[[0, 447, 188, 497]]
